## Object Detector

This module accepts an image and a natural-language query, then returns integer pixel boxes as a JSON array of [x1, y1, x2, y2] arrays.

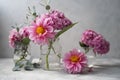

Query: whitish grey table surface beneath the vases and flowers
[[0, 59, 120, 80]]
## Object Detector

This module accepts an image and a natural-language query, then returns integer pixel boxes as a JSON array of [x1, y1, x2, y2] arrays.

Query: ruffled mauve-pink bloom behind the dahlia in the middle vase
[[43, 10, 72, 30]]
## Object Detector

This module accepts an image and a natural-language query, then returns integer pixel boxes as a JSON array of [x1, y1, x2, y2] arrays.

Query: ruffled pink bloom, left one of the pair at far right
[[81, 30, 99, 47]]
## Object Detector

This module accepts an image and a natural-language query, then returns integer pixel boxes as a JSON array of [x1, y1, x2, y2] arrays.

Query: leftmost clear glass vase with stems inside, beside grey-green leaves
[[13, 42, 33, 71]]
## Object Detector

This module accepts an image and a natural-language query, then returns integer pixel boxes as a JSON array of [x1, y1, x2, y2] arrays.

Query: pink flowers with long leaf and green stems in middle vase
[[29, 10, 76, 69]]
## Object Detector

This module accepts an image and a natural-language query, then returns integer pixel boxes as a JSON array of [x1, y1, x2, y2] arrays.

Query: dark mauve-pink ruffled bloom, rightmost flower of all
[[93, 36, 110, 54]]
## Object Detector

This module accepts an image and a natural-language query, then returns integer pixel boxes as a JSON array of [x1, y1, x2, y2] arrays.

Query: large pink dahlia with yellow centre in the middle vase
[[29, 16, 55, 44]]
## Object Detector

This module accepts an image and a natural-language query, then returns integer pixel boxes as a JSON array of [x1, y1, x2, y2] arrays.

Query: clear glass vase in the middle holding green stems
[[40, 38, 62, 70]]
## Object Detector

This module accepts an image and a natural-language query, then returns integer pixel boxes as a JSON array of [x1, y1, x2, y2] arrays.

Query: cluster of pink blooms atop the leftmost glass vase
[[9, 27, 30, 48]]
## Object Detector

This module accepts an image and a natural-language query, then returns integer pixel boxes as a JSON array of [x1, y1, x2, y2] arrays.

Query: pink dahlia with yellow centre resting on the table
[[63, 49, 87, 74]]
